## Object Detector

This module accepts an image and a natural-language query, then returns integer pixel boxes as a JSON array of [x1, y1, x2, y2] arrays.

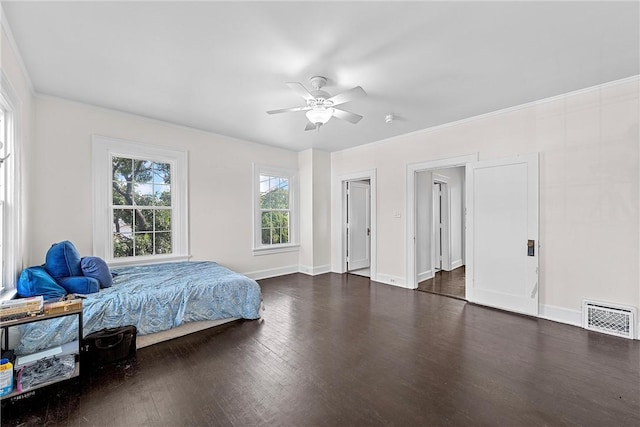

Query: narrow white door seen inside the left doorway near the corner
[[347, 181, 371, 271]]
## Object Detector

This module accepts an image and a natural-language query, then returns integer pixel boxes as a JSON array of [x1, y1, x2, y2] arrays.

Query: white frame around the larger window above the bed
[[92, 135, 190, 265]]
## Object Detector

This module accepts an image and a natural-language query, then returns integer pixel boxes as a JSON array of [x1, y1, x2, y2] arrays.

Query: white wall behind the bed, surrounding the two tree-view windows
[[27, 97, 298, 277]]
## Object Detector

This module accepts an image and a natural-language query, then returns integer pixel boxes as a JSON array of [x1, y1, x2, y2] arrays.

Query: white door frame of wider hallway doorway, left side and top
[[405, 153, 479, 289]]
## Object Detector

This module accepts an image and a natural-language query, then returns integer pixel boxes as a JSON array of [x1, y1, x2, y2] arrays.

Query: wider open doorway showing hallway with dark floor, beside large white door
[[415, 167, 465, 299]]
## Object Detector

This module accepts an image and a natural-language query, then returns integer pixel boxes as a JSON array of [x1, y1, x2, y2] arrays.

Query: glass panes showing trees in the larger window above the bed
[[111, 157, 173, 258]]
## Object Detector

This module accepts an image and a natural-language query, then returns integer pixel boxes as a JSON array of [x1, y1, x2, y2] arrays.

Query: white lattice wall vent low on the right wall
[[582, 300, 636, 339]]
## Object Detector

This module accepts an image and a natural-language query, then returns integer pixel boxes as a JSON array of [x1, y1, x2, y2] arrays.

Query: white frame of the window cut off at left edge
[[0, 69, 23, 299]]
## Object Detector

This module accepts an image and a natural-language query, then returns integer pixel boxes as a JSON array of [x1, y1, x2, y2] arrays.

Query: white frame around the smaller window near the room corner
[[253, 164, 300, 255]]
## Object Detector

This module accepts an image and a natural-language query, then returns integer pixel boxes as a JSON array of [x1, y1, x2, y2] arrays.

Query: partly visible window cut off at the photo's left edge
[[0, 70, 22, 298]]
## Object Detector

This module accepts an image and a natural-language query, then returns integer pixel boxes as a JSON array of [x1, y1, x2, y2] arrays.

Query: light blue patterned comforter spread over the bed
[[15, 262, 262, 354]]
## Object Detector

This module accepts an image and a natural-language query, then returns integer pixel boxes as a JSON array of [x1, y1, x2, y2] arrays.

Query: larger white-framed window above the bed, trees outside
[[93, 137, 188, 264]]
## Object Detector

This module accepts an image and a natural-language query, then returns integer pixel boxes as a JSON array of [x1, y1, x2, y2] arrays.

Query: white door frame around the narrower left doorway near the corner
[[332, 169, 378, 281]]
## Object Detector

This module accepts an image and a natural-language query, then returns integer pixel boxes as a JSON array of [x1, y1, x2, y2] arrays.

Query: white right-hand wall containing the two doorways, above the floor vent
[[331, 77, 640, 316]]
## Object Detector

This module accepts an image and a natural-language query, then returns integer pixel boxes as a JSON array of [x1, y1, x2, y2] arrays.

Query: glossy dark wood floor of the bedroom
[[2, 274, 640, 426]]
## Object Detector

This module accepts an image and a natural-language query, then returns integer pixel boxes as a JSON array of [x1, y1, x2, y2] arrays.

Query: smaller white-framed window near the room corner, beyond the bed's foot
[[254, 165, 298, 254]]
